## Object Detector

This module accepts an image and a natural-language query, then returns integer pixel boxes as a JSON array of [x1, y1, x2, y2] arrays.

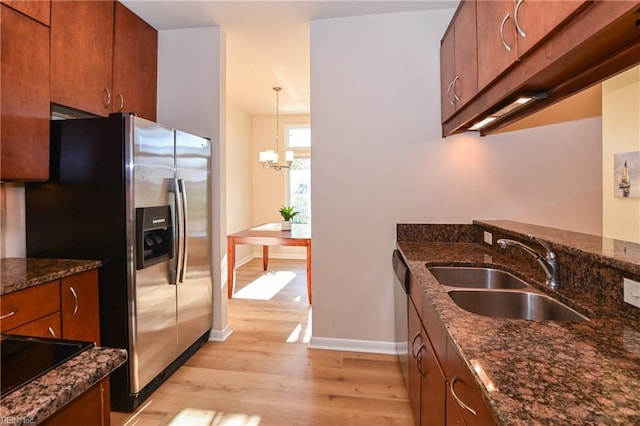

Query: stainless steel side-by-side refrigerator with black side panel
[[25, 114, 212, 412]]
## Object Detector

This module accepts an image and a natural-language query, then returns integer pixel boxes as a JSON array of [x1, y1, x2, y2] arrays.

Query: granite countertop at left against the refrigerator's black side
[[0, 258, 102, 295]]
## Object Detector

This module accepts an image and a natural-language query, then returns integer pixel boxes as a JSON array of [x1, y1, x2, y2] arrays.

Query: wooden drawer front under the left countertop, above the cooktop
[[0, 281, 60, 336]]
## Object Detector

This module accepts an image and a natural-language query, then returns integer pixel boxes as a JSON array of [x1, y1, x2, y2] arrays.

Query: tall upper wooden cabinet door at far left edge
[[0, 2, 50, 180]]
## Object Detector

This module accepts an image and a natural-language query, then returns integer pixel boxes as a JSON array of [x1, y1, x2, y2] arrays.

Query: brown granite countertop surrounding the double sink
[[397, 241, 640, 425]]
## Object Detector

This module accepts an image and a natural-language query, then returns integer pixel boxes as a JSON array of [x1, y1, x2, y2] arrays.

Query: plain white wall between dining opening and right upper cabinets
[[311, 10, 601, 350]]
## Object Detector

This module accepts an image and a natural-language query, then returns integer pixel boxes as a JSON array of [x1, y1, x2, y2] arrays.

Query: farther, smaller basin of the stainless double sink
[[429, 266, 527, 289]]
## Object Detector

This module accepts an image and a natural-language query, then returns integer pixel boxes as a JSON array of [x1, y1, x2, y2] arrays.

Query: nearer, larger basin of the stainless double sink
[[448, 290, 588, 321]]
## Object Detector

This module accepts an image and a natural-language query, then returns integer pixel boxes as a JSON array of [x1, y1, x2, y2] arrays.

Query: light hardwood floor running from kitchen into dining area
[[111, 259, 413, 426]]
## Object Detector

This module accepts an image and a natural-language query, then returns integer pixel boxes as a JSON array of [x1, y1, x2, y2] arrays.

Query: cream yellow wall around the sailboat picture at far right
[[602, 66, 640, 243]]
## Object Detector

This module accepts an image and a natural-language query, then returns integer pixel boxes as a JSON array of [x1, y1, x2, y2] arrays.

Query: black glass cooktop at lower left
[[0, 335, 95, 397]]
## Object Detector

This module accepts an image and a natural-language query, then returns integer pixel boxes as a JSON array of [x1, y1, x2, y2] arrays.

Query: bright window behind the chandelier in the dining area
[[285, 124, 311, 223]]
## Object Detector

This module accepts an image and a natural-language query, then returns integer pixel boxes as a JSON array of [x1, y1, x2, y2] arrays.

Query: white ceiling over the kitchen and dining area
[[120, 0, 458, 115]]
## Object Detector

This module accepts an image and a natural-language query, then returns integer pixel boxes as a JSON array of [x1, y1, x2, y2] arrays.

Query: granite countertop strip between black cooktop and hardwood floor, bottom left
[[0, 347, 127, 424]]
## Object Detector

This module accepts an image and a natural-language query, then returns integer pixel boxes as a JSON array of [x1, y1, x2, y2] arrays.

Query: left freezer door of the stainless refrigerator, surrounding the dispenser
[[125, 116, 178, 394]]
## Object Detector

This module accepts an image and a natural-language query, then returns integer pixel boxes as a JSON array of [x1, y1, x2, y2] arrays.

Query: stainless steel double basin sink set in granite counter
[[428, 266, 588, 321]]
